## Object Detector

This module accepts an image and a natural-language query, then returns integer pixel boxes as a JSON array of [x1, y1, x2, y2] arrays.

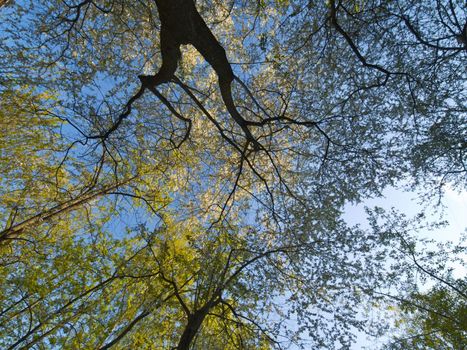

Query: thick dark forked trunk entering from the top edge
[[140, 0, 261, 150]]
